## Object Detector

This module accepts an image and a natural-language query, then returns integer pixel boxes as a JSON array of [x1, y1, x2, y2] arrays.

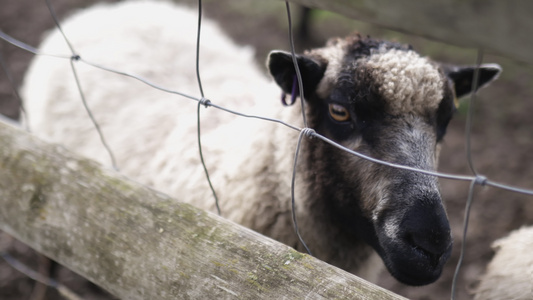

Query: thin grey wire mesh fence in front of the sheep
[[0, 0, 533, 299]]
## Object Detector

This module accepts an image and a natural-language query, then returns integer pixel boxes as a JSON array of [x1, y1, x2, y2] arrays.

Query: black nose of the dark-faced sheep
[[400, 196, 452, 264]]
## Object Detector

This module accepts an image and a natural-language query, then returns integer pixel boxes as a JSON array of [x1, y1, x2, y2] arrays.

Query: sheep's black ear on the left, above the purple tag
[[267, 51, 326, 95]]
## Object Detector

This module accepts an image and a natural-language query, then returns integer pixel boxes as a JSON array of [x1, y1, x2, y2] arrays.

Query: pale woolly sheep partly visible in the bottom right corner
[[474, 227, 533, 300]]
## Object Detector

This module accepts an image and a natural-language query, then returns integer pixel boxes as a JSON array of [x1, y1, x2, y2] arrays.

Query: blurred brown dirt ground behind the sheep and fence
[[0, 0, 533, 300]]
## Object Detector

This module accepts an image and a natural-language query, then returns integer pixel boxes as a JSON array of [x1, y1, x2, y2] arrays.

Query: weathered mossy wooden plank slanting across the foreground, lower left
[[0, 122, 403, 299]]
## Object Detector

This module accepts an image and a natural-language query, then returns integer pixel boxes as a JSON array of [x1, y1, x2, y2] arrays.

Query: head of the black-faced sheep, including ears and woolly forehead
[[267, 35, 501, 285]]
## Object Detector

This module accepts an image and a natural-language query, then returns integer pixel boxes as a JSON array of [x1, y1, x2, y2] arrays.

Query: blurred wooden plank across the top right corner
[[277, 0, 533, 63]]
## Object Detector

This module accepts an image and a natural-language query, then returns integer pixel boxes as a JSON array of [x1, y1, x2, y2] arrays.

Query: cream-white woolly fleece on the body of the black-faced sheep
[[22, 1, 382, 281]]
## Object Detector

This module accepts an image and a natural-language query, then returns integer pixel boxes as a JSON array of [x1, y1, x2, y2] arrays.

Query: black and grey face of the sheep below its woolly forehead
[[307, 74, 455, 285]]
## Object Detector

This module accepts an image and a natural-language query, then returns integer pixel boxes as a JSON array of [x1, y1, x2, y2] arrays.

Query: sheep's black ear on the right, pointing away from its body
[[444, 64, 502, 98]]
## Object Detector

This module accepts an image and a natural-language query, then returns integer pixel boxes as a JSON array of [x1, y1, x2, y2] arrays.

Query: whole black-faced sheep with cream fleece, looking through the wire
[[22, 1, 500, 285]]
